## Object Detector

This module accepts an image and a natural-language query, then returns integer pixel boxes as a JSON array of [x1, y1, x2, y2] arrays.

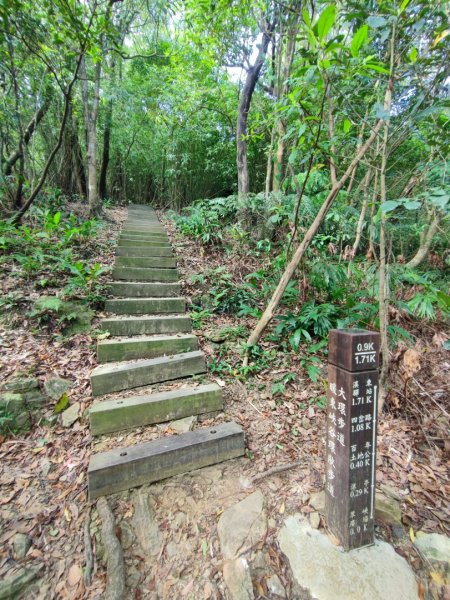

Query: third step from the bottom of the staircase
[[91, 351, 206, 396]]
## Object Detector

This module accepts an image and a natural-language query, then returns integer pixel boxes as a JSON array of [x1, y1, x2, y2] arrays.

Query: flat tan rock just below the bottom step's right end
[[217, 490, 267, 559]]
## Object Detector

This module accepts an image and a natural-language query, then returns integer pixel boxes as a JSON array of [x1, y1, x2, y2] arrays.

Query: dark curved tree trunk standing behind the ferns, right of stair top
[[236, 21, 275, 196]]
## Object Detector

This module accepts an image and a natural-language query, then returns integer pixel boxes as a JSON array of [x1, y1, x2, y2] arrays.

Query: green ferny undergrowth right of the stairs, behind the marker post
[[171, 191, 450, 391]]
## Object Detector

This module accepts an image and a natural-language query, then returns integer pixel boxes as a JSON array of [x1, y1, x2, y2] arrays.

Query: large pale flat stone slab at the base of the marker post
[[278, 515, 418, 600]]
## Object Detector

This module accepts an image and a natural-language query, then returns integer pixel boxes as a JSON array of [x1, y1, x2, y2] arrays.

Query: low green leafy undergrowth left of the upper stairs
[[0, 193, 109, 332]]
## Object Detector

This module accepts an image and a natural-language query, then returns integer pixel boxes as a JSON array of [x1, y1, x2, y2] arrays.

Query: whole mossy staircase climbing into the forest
[[88, 205, 245, 500]]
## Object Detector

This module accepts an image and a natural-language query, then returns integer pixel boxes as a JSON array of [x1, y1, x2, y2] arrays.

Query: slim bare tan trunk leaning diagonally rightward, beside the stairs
[[244, 120, 383, 365]]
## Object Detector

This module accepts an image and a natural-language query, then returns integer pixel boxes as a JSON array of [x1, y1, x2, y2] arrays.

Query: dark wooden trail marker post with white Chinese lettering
[[325, 329, 380, 550]]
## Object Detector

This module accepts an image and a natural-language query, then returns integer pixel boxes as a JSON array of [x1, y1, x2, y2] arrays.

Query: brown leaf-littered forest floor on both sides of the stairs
[[0, 203, 450, 600]]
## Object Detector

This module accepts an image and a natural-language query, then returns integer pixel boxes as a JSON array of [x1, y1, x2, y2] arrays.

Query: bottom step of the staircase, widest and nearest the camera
[[88, 422, 245, 502]]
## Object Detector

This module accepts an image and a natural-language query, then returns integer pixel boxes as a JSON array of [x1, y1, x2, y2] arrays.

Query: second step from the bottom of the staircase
[[89, 383, 223, 435]]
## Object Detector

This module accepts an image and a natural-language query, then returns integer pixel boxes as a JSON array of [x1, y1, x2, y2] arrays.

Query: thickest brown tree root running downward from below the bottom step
[[97, 498, 125, 600]]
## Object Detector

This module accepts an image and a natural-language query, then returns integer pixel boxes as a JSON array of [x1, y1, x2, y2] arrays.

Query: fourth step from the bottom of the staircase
[[97, 333, 198, 363]]
